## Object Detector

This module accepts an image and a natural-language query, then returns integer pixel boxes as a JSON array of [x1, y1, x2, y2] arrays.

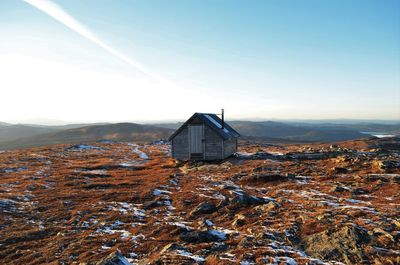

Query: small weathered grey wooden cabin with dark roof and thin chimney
[[168, 112, 240, 160]]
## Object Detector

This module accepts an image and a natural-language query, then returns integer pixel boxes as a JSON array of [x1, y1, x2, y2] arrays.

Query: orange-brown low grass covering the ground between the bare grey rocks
[[0, 137, 400, 264]]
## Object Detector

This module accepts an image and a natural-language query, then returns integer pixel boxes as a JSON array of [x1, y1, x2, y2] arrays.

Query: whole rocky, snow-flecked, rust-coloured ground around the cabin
[[0, 138, 400, 264]]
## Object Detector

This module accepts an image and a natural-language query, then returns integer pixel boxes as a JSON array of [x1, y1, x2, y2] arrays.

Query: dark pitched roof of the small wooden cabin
[[168, 112, 240, 141]]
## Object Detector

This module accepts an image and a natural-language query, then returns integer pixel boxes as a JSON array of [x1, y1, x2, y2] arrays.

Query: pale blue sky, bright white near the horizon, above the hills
[[0, 0, 400, 121]]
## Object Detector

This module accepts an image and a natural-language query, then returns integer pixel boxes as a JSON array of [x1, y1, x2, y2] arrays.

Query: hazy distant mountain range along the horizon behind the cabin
[[0, 121, 400, 150]]
